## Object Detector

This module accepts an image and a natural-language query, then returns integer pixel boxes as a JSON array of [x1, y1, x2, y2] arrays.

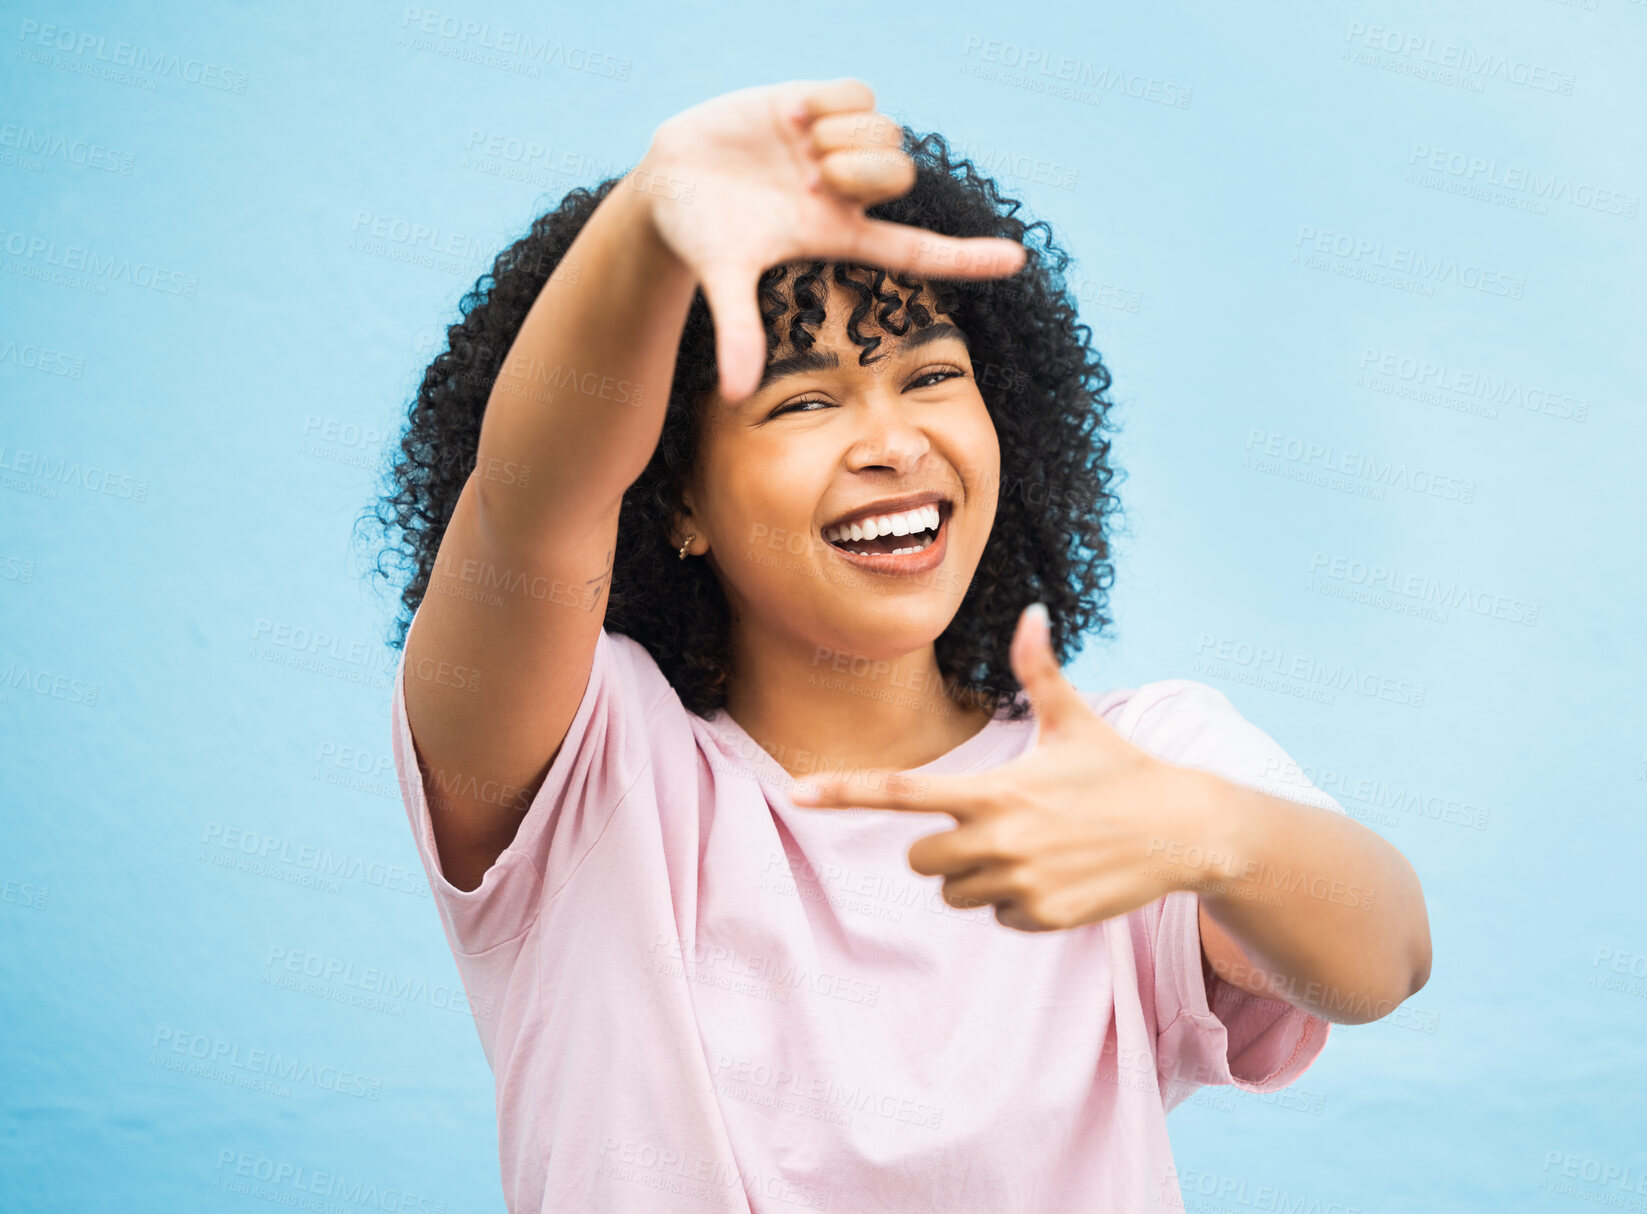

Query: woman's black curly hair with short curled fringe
[[369, 127, 1120, 718]]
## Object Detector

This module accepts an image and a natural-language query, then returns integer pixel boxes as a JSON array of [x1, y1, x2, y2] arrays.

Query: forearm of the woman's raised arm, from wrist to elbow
[[473, 160, 697, 549]]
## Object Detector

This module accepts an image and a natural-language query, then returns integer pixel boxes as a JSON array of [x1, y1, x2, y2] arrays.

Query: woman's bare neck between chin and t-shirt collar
[[726, 609, 991, 779]]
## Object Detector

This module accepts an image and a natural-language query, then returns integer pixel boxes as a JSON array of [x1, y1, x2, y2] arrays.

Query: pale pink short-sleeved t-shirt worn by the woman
[[394, 619, 1342, 1214]]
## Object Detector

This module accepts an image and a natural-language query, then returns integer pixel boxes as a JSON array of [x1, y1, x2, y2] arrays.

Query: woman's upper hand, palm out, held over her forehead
[[628, 77, 1026, 402]]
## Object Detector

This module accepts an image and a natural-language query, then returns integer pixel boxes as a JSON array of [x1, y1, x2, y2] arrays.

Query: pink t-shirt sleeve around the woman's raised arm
[[392, 618, 656, 957]]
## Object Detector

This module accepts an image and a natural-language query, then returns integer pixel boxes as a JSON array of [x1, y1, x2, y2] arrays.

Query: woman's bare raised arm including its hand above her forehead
[[405, 79, 1024, 889]]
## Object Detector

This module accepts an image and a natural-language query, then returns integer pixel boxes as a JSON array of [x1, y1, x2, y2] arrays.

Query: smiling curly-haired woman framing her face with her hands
[[373, 79, 1430, 1214]]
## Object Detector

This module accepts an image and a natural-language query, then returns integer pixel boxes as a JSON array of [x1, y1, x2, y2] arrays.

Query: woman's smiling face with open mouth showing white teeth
[[675, 265, 1000, 659]]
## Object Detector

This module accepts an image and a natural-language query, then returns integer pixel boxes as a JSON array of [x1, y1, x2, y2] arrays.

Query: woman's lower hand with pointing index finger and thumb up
[[791, 605, 1220, 931]]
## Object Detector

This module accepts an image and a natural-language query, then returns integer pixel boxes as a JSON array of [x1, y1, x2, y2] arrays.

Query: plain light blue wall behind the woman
[[0, 0, 1647, 1211]]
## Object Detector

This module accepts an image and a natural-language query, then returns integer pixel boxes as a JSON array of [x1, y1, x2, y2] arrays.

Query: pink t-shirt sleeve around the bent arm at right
[[1128, 679, 1344, 1110]]
